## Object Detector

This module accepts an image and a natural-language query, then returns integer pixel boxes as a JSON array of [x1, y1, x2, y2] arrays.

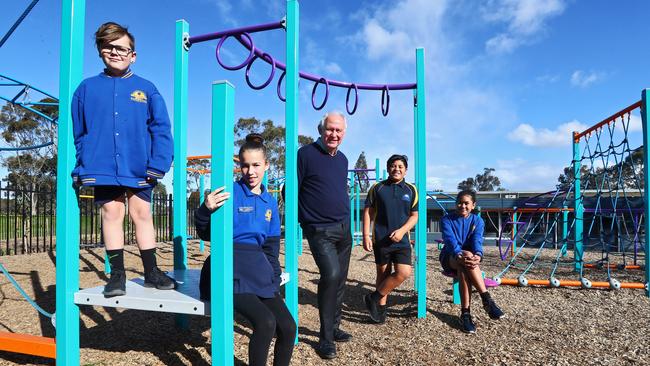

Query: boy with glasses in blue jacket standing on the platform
[[72, 22, 175, 297]]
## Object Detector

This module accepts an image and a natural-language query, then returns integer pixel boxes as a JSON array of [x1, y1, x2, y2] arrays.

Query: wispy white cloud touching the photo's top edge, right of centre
[[482, 0, 565, 53]]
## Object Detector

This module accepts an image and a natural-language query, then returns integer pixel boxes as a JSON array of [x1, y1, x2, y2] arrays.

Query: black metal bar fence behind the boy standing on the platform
[[0, 186, 199, 255]]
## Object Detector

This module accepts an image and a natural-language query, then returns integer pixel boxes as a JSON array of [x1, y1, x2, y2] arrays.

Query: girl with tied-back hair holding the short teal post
[[194, 134, 296, 366]]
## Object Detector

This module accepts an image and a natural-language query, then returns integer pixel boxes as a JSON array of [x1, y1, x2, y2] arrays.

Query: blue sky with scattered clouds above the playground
[[0, 0, 650, 191]]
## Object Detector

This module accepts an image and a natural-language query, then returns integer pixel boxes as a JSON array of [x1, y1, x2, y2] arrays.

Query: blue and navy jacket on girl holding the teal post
[[194, 180, 282, 300]]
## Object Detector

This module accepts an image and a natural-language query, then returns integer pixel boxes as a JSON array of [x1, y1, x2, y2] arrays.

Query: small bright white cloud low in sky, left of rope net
[[508, 120, 588, 147]]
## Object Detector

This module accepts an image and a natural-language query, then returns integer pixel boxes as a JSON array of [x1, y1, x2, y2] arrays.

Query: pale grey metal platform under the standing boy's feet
[[74, 269, 210, 315]]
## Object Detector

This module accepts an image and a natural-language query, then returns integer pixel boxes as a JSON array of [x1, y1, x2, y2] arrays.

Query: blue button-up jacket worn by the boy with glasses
[[72, 71, 174, 188]]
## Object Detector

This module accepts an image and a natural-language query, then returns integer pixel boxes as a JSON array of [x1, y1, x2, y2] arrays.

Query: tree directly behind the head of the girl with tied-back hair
[[235, 117, 314, 179]]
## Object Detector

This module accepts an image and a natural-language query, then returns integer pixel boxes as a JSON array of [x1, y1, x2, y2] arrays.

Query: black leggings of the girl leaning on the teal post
[[233, 294, 296, 366]]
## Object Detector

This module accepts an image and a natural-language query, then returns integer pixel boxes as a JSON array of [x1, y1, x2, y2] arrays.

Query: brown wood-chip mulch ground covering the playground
[[0, 242, 650, 366]]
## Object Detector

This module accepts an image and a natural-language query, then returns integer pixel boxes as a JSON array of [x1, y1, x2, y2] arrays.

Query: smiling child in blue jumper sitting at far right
[[440, 190, 504, 333]]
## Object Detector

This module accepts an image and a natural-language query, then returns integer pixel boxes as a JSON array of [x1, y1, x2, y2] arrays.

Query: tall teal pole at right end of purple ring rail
[[414, 48, 427, 318]]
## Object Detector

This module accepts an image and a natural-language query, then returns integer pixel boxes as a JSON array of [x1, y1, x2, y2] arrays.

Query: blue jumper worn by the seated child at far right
[[440, 212, 485, 263]]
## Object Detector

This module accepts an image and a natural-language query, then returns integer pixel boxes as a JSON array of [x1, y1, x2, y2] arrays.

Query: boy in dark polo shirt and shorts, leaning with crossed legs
[[363, 155, 418, 323]]
